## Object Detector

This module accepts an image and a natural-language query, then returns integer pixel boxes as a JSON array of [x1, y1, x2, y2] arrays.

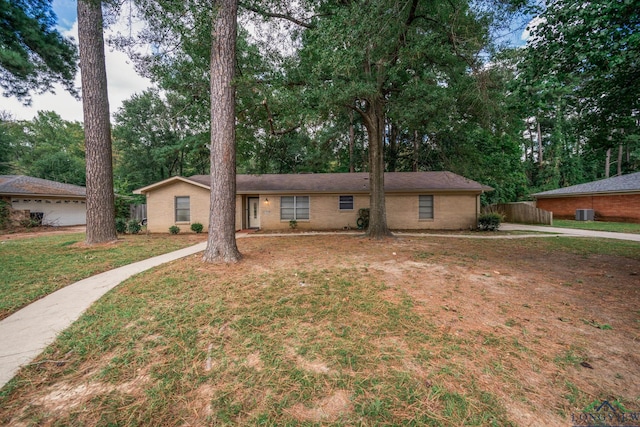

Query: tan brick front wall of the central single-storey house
[[141, 182, 479, 233]]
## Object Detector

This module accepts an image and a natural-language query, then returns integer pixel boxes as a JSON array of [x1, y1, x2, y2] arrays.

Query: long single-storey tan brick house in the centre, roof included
[[134, 172, 492, 233]]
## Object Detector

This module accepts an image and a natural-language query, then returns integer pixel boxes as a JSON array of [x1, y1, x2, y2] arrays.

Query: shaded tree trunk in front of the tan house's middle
[[362, 97, 392, 239]]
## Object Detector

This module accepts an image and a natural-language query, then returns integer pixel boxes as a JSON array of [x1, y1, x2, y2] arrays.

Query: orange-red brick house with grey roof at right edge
[[533, 172, 640, 222]]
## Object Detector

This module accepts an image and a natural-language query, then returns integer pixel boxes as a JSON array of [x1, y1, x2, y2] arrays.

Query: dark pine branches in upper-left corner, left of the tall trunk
[[0, 0, 77, 104]]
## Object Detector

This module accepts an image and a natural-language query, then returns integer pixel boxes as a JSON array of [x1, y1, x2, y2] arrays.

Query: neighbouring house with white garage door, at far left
[[0, 175, 87, 226]]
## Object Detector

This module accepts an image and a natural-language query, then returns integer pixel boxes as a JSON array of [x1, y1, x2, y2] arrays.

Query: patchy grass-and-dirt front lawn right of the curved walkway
[[0, 235, 640, 426]]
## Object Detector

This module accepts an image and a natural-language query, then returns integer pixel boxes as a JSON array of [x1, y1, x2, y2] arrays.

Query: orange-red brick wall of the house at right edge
[[536, 194, 640, 223]]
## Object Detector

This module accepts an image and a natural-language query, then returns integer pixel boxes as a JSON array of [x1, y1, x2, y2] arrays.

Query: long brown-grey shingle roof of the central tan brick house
[[182, 172, 493, 194]]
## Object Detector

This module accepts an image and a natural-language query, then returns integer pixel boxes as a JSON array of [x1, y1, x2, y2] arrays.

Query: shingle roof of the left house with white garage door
[[0, 175, 87, 197]]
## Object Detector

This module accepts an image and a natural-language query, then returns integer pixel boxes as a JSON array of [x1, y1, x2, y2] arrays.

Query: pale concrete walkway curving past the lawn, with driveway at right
[[0, 224, 640, 388]]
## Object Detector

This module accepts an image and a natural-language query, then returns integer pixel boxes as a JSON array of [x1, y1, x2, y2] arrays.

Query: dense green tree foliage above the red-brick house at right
[[517, 0, 640, 181]]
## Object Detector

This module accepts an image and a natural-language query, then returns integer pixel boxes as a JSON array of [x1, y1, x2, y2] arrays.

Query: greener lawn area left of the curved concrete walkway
[[0, 234, 204, 319]]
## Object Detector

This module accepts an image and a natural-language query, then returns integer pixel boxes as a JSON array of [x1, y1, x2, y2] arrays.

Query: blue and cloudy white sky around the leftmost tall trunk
[[0, 0, 151, 122]]
